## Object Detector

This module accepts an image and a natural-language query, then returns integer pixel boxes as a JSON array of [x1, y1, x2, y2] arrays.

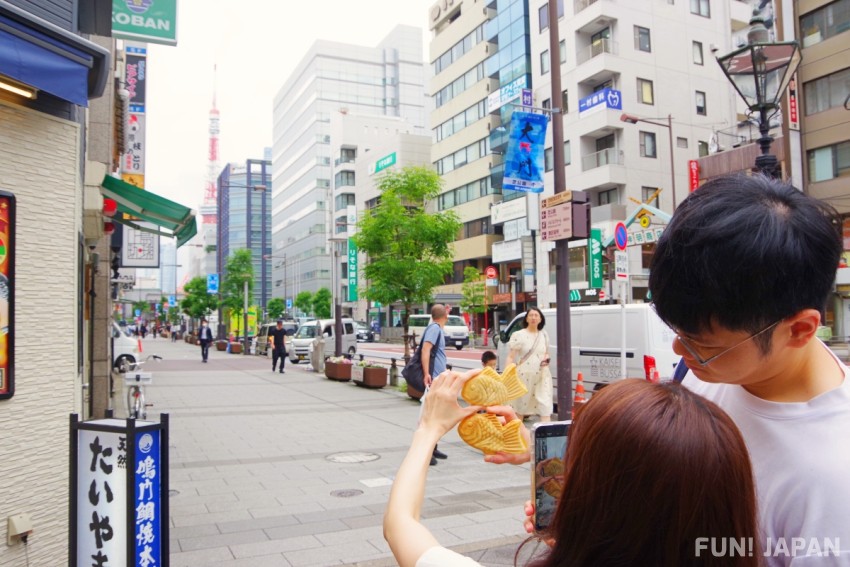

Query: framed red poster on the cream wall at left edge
[[0, 191, 15, 400]]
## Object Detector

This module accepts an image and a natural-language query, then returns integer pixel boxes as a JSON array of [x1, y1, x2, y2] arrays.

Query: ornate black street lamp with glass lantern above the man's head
[[717, 11, 801, 177]]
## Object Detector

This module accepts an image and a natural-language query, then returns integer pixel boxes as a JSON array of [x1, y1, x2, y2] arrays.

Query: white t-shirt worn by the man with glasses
[[683, 346, 850, 567]]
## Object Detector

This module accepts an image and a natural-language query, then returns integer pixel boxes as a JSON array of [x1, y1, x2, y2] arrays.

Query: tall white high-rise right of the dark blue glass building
[[272, 26, 426, 297]]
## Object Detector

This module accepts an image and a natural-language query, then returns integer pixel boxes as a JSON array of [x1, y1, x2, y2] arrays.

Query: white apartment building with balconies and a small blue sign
[[529, 0, 752, 307]]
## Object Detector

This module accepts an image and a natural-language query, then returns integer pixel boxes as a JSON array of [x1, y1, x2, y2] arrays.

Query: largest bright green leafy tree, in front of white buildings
[[353, 167, 462, 358]]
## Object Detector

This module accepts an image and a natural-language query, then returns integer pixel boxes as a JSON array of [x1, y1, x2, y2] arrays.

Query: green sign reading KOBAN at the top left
[[112, 0, 177, 45]]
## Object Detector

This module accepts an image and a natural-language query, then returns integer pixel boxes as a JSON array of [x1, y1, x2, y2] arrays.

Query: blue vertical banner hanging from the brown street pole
[[502, 111, 549, 193]]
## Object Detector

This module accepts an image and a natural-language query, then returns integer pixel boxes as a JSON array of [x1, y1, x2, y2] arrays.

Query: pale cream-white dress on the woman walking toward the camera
[[508, 329, 553, 415]]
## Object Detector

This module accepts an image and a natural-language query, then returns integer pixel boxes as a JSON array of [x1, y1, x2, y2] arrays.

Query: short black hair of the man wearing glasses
[[649, 175, 842, 352]]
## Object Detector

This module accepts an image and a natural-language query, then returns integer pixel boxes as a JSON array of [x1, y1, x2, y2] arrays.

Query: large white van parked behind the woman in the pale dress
[[498, 303, 679, 391]]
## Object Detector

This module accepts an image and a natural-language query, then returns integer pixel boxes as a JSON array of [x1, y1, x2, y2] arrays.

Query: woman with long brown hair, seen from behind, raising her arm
[[384, 371, 761, 567]]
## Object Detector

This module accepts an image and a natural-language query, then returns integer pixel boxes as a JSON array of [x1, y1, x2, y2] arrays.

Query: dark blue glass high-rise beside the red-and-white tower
[[215, 159, 272, 308]]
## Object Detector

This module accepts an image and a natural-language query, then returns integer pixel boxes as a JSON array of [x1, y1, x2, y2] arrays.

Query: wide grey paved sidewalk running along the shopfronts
[[120, 337, 533, 567]]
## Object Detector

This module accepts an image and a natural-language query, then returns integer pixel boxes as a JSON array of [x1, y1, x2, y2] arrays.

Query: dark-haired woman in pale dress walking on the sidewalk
[[505, 307, 553, 421]]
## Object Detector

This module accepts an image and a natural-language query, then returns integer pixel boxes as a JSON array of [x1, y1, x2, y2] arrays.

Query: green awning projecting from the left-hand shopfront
[[100, 175, 198, 248]]
